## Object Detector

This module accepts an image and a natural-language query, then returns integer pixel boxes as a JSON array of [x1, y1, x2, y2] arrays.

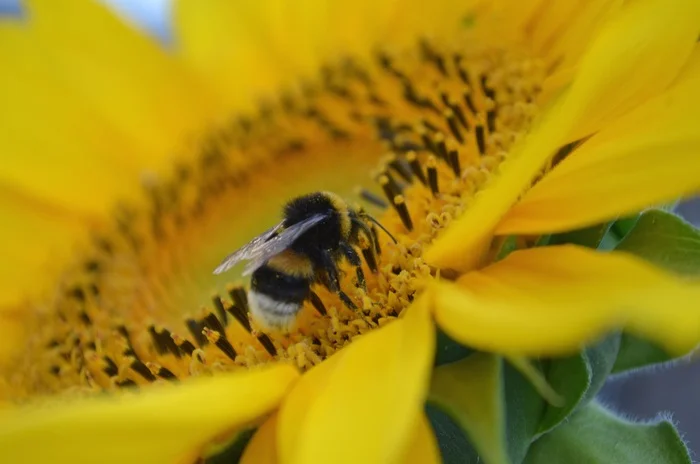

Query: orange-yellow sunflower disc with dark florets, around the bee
[[0, 41, 545, 401]]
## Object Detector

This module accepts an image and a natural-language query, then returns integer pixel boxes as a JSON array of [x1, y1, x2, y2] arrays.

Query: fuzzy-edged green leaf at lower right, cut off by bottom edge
[[525, 403, 691, 464]]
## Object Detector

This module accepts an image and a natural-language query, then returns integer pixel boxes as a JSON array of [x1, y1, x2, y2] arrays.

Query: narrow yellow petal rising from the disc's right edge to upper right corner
[[425, 0, 700, 271]]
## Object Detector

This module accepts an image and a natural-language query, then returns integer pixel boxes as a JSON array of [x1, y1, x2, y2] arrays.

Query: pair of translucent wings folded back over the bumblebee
[[214, 214, 327, 275]]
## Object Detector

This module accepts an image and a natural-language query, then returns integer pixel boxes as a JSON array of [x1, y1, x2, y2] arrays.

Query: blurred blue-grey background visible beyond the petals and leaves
[[0, 0, 700, 461]]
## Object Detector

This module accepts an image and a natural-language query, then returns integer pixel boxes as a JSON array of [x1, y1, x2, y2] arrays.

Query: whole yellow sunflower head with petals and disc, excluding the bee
[[0, 0, 700, 462]]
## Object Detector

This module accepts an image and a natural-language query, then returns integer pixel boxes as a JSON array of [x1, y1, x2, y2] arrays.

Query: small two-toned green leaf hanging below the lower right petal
[[538, 334, 620, 434]]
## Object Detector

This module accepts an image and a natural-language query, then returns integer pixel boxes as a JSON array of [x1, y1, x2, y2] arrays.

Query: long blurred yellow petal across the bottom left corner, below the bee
[[0, 365, 298, 464]]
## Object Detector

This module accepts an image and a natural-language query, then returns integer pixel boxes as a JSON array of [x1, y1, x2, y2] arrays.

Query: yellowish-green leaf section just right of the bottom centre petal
[[428, 353, 509, 464]]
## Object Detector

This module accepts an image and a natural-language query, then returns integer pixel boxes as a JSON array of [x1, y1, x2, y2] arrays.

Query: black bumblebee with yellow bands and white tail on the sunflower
[[214, 192, 396, 332]]
